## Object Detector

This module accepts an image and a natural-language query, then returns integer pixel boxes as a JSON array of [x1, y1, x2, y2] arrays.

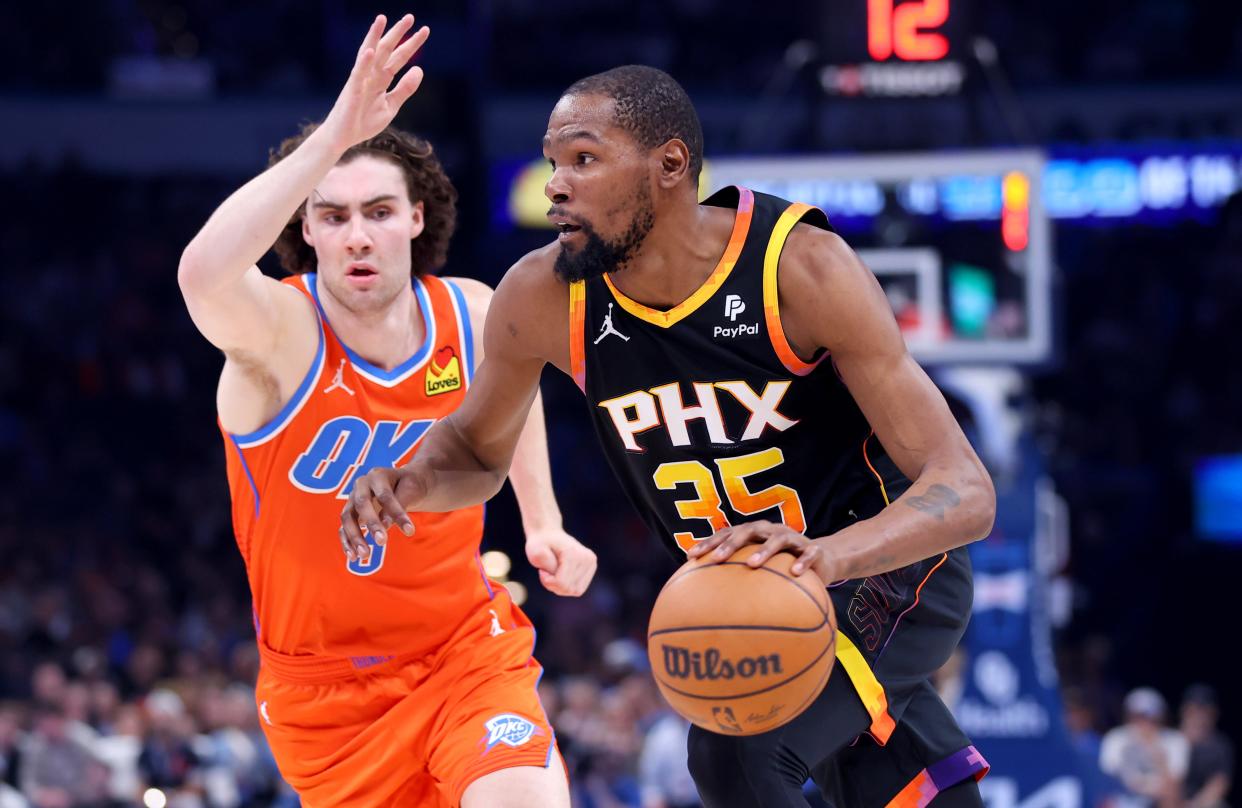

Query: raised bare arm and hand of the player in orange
[[178, 15, 428, 355]]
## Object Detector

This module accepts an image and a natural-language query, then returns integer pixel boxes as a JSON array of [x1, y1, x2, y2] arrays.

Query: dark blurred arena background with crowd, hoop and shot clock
[[0, 0, 1242, 808]]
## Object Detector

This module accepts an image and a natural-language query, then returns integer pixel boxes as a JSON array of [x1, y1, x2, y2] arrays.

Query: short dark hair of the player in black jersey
[[563, 65, 703, 180]]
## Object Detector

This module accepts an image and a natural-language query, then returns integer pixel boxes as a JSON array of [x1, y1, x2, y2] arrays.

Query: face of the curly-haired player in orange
[[302, 155, 424, 312]]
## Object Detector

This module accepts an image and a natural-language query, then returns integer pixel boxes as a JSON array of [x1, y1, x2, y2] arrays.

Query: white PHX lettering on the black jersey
[[599, 381, 797, 453]]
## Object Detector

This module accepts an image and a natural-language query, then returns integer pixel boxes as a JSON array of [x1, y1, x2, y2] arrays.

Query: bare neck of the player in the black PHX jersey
[[610, 205, 735, 310]]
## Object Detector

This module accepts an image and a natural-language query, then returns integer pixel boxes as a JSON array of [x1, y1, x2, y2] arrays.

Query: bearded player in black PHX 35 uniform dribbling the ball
[[340, 67, 995, 808]]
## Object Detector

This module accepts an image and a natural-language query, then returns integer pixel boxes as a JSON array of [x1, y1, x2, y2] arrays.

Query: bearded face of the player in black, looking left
[[543, 96, 658, 281]]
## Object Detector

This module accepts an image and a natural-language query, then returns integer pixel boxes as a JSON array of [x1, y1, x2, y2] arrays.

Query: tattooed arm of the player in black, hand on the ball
[[691, 226, 996, 582]]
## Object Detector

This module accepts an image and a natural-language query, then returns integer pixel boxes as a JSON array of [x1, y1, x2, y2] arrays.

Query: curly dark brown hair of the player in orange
[[267, 123, 457, 277]]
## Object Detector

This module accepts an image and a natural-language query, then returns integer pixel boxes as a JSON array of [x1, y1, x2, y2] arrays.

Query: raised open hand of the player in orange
[[320, 14, 431, 151]]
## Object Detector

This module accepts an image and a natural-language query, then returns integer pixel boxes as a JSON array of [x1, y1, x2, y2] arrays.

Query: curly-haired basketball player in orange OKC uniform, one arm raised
[[179, 16, 595, 808]]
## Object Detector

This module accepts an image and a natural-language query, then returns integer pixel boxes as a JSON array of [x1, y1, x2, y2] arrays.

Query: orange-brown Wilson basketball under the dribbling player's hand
[[647, 545, 837, 735]]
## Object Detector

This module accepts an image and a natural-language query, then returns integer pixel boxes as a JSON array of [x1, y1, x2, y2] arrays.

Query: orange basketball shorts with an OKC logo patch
[[255, 587, 555, 808]]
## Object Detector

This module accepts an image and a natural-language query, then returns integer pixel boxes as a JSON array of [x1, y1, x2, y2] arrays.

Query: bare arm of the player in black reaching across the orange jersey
[[340, 251, 569, 557]]
